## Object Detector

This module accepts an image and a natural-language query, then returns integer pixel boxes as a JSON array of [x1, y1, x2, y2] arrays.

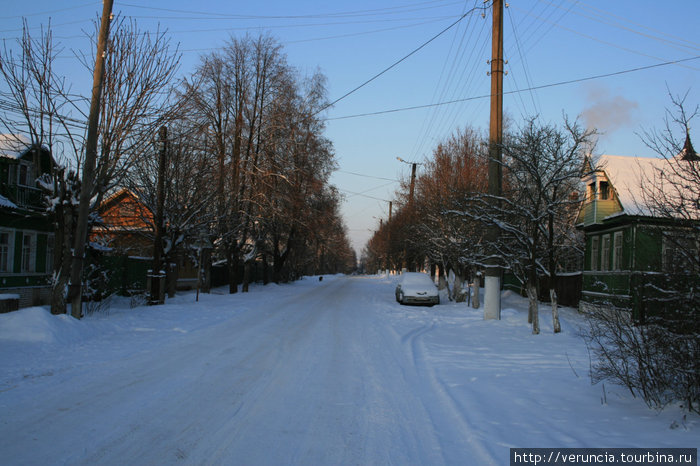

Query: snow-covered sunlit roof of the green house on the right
[[597, 152, 693, 216]]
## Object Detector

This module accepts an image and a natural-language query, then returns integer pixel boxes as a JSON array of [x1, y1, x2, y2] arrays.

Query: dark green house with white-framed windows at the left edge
[[0, 135, 55, 307]]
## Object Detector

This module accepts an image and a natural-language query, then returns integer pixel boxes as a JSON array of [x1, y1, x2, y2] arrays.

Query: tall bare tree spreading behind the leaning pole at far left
[[0, 12, 179, 316]]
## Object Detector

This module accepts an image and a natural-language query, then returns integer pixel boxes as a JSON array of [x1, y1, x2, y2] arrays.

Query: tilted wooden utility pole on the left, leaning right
[[67, 0, 113, 319]]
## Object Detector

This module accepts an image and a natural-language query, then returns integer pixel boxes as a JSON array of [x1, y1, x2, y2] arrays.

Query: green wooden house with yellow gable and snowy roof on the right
[[578, 139, 700, 320]]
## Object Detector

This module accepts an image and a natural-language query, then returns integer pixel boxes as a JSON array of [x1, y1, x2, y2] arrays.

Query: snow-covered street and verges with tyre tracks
[[0, 276, 700, 465]]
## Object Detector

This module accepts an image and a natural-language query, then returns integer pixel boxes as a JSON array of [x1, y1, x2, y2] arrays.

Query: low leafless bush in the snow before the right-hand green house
[[583, 306, 700, 412]]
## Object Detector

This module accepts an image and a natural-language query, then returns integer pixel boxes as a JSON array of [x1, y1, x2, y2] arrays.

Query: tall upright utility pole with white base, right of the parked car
[[484, 0, 504, 320]]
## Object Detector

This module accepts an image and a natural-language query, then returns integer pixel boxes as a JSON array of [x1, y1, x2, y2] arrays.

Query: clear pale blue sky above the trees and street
[[0, 0, 700, 252]]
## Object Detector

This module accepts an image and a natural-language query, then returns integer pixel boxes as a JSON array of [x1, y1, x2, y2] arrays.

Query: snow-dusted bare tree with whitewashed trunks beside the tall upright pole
[[465, 118, 595, 334]]
